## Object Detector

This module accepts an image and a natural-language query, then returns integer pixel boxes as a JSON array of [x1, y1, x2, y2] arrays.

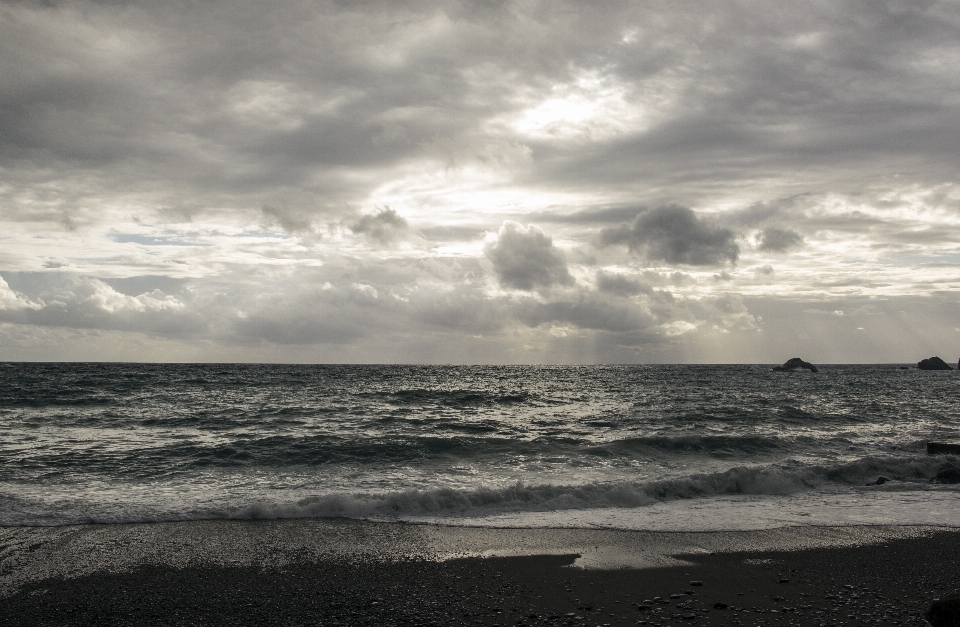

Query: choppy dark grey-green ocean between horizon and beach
[[0, 363, 960, 531]]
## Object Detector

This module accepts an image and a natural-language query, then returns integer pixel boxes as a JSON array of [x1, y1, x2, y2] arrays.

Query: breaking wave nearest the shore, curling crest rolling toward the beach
[[0, 455, 960, 526]]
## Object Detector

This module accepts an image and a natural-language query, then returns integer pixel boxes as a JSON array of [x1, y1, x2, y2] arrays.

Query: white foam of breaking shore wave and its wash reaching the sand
[[0, 456, 960, 530]]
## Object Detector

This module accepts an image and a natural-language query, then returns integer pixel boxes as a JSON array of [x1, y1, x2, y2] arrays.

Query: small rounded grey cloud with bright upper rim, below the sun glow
[[483, 221, 573, 291]]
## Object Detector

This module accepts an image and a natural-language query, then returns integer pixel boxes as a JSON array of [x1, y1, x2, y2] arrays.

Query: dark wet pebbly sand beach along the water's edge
[[0, 522, 960, 627]]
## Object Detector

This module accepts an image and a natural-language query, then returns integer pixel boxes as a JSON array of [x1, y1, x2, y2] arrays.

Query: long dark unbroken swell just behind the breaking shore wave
[[0, 434, 804, 479]]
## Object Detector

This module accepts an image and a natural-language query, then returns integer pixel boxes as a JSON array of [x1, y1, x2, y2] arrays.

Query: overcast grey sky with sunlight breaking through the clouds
[[0, 0, 960, 364]]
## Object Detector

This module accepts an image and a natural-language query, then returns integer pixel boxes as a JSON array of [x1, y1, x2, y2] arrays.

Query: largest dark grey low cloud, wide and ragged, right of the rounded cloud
[[600, 205, 740, 266]]
